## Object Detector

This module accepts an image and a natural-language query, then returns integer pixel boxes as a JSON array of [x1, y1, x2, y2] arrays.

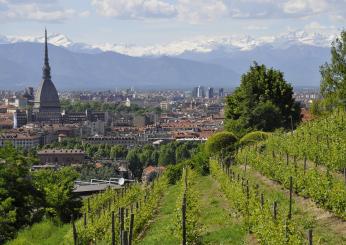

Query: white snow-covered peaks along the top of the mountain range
[[0, 31, 336, 57]]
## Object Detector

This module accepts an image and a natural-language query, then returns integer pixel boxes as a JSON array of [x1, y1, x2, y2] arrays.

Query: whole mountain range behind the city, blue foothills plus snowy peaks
[[0, 32, 335, 89]]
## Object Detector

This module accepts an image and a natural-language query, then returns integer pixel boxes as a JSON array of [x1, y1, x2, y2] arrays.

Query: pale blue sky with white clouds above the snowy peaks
[[0, 0, 346, 45]]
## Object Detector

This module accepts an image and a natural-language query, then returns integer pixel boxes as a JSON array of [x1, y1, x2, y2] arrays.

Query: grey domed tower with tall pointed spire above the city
[[33, 30, 60, 113]]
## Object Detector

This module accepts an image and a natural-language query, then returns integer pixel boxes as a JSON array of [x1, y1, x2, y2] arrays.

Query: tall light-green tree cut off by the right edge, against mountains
[[320, 31, 346, 104]]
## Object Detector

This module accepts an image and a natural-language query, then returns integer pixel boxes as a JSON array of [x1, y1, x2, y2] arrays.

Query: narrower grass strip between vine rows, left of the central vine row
[[136, 185, 180, 245]]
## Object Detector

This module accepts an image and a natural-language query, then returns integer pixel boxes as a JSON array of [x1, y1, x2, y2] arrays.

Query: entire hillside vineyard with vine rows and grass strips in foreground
[[8, 111, 346, 245]]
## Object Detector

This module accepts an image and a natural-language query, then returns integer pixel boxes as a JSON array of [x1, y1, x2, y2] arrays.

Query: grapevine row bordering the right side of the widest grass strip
[[210, 160, 311, 244]]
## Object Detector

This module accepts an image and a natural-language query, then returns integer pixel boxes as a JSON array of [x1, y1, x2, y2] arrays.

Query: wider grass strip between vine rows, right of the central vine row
[[196, 176, 247, 245]]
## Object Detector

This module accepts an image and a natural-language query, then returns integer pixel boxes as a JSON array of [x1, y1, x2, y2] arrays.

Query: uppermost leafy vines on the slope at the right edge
[[266, 110, 346, 171]]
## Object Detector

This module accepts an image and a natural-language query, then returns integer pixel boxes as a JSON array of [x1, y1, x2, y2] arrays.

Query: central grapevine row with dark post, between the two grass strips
[[174, 169, 202, 244]]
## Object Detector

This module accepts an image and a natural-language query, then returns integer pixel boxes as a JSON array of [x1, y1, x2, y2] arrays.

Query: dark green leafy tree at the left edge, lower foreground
[[0, 144, 42, 244]]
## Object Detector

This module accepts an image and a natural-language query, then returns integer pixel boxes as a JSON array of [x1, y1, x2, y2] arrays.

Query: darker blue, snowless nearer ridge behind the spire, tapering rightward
[[0, 43, 239, 90]]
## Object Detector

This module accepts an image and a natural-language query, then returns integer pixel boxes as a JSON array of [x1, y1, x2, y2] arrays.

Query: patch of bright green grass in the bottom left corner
[[6, 220, 71, 245]]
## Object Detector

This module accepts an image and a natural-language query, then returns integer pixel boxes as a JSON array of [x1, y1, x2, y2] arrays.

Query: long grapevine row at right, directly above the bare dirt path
[[236, 146, 346, 219]]
